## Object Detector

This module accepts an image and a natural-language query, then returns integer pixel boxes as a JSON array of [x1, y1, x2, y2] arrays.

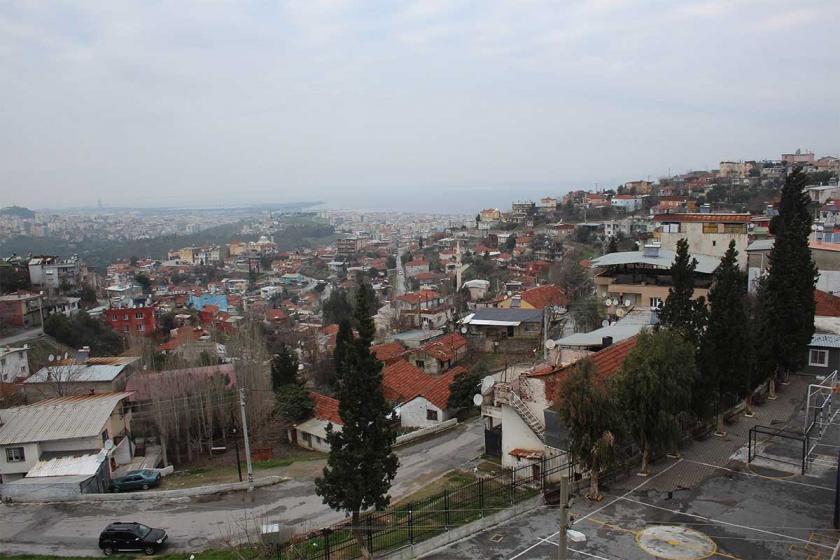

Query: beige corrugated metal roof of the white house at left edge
[[0, 393, 129, 445]]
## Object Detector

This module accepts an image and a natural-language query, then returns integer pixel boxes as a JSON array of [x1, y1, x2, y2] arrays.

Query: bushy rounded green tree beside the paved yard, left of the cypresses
[[615, 329, 697, 474]]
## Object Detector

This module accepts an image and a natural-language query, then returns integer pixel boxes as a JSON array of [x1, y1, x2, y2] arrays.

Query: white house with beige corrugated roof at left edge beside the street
[[0, 393, 134, 490]]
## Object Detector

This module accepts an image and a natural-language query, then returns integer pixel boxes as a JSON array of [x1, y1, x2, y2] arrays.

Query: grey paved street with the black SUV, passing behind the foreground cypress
[[0, 421, 483, 556]]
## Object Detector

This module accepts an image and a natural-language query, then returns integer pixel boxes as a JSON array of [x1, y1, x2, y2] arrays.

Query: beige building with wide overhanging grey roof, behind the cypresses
[[591, 243, 720, 308]]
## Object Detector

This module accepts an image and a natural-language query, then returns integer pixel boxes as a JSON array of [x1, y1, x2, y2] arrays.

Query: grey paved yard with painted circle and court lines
[[426, 378, 840, 560]]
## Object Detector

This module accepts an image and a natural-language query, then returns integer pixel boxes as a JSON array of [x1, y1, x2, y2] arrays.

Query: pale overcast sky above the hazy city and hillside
[[0, 0, 840, 212]]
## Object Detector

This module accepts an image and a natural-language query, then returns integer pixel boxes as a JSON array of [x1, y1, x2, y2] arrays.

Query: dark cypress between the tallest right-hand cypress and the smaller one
[[693, 239, 752, 433]]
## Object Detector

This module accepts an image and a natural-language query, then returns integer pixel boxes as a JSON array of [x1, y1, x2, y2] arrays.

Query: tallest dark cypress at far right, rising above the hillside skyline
[[757, 168, 817, 391]]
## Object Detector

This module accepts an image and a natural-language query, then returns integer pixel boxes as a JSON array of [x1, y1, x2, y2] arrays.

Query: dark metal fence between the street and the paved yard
[[275, 455, 572, 560]]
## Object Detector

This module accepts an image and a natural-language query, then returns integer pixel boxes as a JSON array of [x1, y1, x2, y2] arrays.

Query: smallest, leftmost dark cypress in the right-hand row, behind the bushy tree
[[659, 238, 706, 342]]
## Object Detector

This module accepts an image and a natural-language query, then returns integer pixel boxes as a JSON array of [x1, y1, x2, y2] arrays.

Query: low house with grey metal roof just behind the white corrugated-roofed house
[[21, 356, 140, 402]]
